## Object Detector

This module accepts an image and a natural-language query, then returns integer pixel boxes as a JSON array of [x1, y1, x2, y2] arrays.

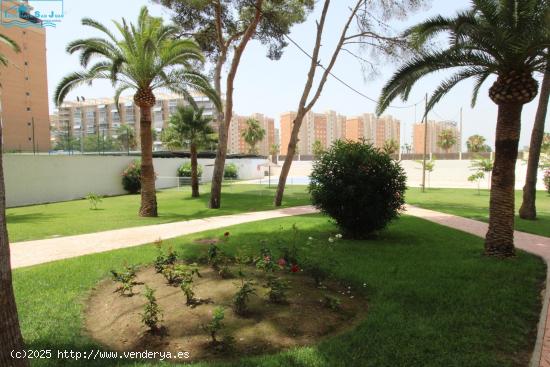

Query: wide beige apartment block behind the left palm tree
[[51, 93, 215, 151]]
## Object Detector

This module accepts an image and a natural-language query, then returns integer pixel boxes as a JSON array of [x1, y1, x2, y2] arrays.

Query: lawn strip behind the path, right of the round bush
[[406, 188, 550, 237]]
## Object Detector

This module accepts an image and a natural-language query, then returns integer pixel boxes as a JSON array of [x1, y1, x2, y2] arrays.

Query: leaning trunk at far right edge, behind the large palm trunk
[[519, 68, 550, 220]]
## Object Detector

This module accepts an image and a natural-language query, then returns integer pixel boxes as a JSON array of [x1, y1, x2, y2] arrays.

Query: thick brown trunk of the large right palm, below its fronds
[[485, 103, 523, 257]]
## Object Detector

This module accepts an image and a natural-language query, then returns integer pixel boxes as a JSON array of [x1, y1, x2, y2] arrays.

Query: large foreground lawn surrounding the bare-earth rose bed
[[14, 215, 545, 367]]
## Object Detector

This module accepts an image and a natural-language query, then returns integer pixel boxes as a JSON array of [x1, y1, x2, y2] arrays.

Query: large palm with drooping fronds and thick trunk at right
[[378, 0, 550, 257]]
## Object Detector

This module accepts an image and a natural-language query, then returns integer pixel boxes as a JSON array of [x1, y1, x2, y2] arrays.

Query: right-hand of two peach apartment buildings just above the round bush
[[346, 113, 401, 148]]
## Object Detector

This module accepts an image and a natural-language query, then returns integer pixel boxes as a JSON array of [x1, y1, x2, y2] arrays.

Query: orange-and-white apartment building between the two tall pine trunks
[[227, 113, 276, 156]]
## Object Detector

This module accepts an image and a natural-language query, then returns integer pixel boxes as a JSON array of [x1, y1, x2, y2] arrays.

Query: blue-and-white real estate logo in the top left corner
[[0, 0, 64, 28]]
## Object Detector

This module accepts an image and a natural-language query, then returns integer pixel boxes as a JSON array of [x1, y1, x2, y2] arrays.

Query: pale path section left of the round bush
[[10, 206, 316, 268]]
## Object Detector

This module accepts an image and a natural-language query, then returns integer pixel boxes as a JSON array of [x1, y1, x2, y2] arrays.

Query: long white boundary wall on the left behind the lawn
[[4, 154, 267, 207]]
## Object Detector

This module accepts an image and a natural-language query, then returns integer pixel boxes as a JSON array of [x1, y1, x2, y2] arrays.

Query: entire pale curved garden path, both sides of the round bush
[[10, 206, 550, 367]]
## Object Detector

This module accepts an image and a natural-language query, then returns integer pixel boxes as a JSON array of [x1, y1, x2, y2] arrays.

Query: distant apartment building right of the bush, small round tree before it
[[413, 120, 460, 154]]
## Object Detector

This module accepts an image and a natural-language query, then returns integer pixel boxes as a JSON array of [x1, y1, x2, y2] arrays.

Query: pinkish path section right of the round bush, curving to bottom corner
[[406, 206, 550, 367]]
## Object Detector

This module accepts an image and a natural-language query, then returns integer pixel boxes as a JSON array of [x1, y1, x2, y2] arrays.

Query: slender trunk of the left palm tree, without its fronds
[[139, 105, 158, 217]]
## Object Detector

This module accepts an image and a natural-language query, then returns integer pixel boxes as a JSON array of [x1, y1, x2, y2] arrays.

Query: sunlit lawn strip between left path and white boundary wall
[[7, 184, 309, 242]]
